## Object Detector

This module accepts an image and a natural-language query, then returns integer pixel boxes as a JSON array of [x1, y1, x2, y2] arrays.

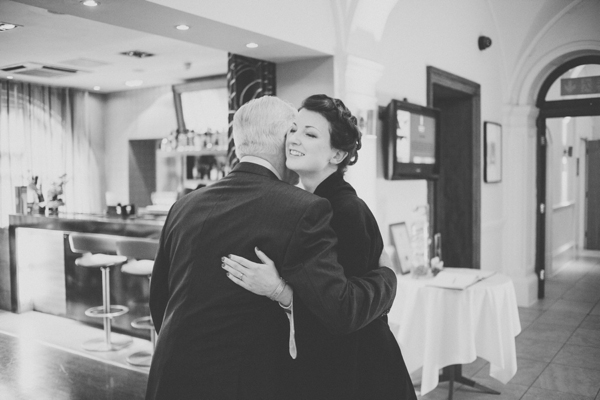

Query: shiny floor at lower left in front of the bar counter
[[0, 311, 152, 400]]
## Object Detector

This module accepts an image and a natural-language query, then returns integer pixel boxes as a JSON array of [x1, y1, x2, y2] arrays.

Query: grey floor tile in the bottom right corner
[[533, 364, 600, 397]]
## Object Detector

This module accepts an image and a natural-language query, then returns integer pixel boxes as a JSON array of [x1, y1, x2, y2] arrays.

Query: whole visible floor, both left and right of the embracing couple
[[0, 253, 600, 400]]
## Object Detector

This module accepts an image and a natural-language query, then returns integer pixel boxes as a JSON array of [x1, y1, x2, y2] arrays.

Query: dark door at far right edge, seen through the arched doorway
[[585, 140, 600, 250]]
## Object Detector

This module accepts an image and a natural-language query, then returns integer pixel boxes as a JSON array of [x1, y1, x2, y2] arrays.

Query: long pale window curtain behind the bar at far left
[[0, 80, 104, 227]]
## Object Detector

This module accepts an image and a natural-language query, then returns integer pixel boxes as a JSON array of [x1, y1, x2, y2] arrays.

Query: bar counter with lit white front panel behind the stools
[[8, 213, 164, 338]]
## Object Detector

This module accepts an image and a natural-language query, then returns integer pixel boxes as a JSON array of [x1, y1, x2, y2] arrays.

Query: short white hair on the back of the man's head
[[233, 96, 298, 158]]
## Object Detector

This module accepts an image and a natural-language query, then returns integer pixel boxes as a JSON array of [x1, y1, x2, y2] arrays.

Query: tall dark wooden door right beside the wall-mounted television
[[428, 67, 481, 269]]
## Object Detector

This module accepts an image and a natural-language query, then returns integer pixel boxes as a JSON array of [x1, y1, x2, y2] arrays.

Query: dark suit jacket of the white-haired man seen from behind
[[146, 162, 396, 400]]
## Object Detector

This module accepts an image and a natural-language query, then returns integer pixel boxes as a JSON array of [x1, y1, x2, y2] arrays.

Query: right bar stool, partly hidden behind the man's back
[[117, 238, 158, 367]]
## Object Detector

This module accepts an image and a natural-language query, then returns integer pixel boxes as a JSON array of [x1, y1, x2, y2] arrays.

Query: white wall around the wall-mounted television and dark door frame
[[348, 0, 510, 271]]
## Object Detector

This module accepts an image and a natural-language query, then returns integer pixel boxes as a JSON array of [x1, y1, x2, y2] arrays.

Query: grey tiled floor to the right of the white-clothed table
[[417, 252, 600, 400]]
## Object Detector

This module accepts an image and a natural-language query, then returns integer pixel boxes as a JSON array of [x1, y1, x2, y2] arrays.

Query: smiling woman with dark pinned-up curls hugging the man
[[224, 94, 416, 400]]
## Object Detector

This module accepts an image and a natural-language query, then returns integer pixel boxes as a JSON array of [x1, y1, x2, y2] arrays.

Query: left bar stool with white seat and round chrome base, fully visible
[[69, 233, 133, 351]]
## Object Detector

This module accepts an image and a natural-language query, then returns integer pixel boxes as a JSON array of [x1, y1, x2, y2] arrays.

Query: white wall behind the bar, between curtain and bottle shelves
[[104, 86, 177, 204]]
